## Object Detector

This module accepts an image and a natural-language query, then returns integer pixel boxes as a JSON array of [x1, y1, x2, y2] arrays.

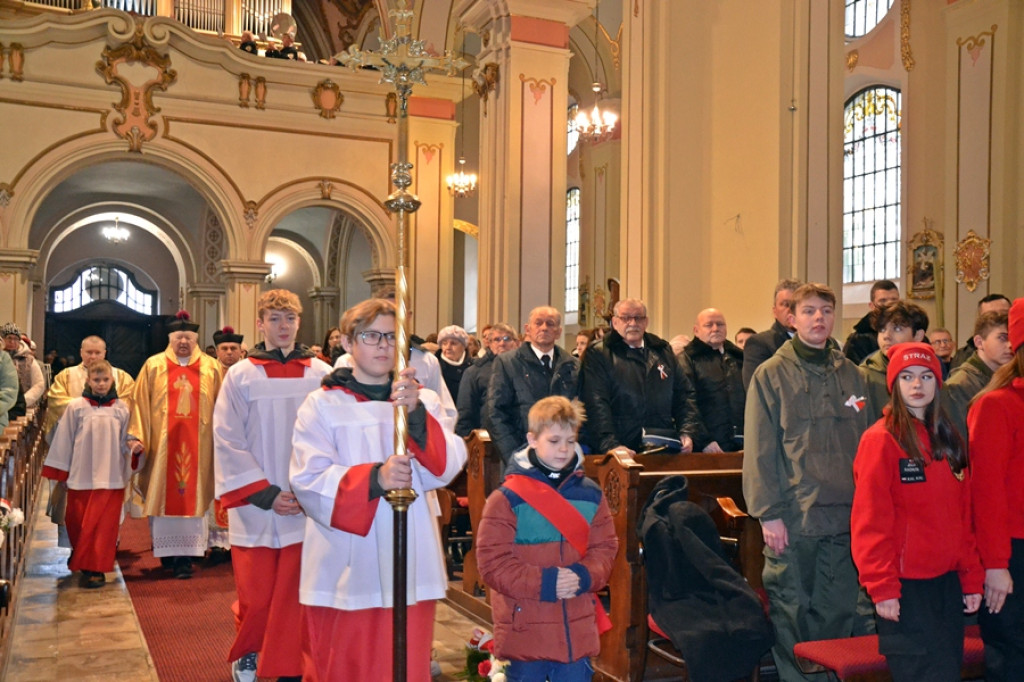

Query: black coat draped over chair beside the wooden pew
[[638, 476, 775, 682]]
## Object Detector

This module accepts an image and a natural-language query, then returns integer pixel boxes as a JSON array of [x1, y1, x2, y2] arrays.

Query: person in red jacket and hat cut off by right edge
[[967, 298, 1024, 682]]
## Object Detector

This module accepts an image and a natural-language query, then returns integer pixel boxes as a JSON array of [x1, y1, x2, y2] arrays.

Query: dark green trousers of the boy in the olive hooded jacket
[[762, 534, 865, 682]]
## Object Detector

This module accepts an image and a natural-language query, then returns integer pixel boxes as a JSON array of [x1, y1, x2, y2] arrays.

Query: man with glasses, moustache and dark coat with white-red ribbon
[[580, 298, 698, 453]]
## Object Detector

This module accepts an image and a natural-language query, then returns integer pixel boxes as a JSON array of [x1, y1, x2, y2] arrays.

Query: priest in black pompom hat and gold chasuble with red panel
[[128, 311, 221, 579]]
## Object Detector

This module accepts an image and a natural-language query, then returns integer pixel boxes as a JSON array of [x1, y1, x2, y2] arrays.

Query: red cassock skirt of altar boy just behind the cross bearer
[[227, 543, 306, 677]]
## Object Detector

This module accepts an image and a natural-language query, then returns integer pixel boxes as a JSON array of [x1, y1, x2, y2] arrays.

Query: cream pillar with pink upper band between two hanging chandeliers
[[460, 0, 595, 328]]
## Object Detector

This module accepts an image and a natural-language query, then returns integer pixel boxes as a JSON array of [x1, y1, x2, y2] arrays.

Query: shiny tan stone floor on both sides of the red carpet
[[0, 484, 487, 682]]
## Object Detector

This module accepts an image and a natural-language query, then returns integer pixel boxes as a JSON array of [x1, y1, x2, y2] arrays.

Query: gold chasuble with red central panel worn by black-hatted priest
[[128, 347, 222, 516]]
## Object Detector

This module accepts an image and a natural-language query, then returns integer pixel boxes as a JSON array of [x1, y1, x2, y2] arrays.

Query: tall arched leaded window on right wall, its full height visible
[[843, 86, 902, 284]]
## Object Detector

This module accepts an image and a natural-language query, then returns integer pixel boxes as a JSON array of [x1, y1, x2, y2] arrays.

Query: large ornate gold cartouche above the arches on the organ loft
[[96, 17, 177, 152]]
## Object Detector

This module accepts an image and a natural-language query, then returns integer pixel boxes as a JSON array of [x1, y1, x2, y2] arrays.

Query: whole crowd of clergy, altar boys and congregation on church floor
[[18, 280, 1024, 680]]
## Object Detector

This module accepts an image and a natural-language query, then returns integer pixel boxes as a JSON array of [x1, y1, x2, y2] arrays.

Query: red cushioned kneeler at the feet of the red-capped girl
[[793, 626, 985, 682]]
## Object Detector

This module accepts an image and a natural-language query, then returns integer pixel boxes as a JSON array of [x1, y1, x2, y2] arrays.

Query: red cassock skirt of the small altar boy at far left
[[65, 489, 125, 573]]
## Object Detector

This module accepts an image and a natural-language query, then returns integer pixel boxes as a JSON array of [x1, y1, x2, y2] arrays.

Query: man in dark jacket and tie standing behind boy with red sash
[[483, 305, 580, 463]]
